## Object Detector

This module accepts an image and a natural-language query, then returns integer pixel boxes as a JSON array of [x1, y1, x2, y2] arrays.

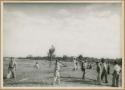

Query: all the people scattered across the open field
[[7, 58, 121, 87]]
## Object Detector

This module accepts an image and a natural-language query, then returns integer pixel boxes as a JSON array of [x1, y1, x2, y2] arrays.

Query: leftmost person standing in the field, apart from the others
[[7, 57, 16, 78]]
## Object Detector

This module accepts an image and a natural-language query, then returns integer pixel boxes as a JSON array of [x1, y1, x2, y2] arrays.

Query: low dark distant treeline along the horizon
[[4, 55, 122, 64]]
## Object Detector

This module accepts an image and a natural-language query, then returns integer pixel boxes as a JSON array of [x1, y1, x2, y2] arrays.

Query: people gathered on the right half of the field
[[73, 58, 121, 87]]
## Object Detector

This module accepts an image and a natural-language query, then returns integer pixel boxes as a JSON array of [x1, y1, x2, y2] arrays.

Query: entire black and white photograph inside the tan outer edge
[[2, 1, 124, 88]]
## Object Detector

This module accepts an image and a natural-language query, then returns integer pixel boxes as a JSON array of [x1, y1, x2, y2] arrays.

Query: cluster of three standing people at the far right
[[96, 59, 121, 87]]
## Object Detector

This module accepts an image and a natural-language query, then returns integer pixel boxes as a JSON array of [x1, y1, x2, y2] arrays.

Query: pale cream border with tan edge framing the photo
[[0, 0, 125, 90]]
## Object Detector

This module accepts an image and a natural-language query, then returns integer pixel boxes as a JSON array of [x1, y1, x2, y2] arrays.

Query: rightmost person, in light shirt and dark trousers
[[112, 61, 121, 87]]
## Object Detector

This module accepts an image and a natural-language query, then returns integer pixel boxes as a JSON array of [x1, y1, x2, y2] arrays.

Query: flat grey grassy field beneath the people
[[3, 59, 121, 87]]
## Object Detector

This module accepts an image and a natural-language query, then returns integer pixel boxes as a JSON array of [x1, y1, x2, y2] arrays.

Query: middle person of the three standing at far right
[[101, 59, 108, 83]]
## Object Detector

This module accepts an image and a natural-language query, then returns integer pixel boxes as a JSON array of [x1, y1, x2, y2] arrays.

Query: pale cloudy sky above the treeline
[[3, 3, 121, 58]]
